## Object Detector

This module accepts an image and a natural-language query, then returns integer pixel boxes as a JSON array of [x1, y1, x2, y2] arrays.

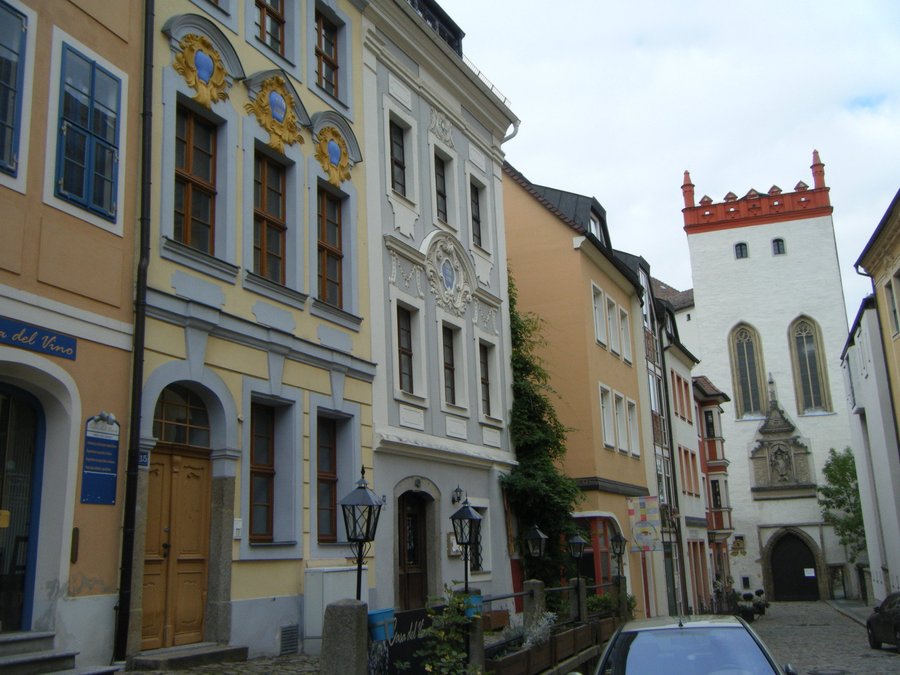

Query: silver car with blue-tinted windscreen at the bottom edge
[[595, 615, 796, 675]]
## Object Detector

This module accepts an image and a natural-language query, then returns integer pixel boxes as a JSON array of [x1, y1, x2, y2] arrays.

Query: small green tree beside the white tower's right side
[[818, 448, 866, 562]]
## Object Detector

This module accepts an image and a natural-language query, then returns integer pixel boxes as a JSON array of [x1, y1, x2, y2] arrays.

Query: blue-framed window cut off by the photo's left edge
[[0, 2, 28, 176]]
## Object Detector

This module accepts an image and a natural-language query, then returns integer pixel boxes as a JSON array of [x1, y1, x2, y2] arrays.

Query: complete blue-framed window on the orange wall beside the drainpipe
[[56, 45, 122, 221]]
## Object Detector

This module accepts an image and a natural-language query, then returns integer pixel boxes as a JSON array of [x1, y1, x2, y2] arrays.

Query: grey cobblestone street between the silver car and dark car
[[752, 601, 900, 675]]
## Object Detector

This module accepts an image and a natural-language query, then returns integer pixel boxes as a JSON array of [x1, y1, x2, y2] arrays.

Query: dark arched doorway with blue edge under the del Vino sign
[[0, 387, 43, 632]]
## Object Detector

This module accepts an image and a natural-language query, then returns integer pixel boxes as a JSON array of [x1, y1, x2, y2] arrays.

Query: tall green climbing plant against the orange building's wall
[[501, 275, 581, 586]]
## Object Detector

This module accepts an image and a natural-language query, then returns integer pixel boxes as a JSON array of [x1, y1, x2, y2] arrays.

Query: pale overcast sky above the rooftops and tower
[[440, 0, 900, 321]]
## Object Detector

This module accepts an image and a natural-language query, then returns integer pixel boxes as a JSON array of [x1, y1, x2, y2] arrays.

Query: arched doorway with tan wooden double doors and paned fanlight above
[[141, 384, 212, 649]]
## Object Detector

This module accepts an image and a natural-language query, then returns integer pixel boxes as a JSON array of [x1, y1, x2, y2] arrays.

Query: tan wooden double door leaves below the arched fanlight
[[141, 446, 210, 649]]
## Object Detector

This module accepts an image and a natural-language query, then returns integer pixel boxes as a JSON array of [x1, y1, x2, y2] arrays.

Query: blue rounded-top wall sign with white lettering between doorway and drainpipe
[[81, 413, 119, 504]]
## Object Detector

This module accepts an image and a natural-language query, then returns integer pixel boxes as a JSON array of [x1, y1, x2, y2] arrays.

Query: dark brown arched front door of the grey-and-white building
[[397, 492, 428, 610]]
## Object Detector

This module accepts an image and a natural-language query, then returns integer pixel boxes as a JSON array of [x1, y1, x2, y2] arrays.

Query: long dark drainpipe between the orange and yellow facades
[[113, 0, 155, 661]]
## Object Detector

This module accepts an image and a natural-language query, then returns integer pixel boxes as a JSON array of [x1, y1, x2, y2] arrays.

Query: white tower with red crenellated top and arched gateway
[[678, 152, 859, 600]]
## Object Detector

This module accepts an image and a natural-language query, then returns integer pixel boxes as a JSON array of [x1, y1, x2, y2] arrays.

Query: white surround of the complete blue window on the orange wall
[[43, 26, 130, 237]]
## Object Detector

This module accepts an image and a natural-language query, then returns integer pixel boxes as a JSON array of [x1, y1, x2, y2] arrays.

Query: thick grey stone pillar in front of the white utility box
[[321, 599, 369, 675]]
